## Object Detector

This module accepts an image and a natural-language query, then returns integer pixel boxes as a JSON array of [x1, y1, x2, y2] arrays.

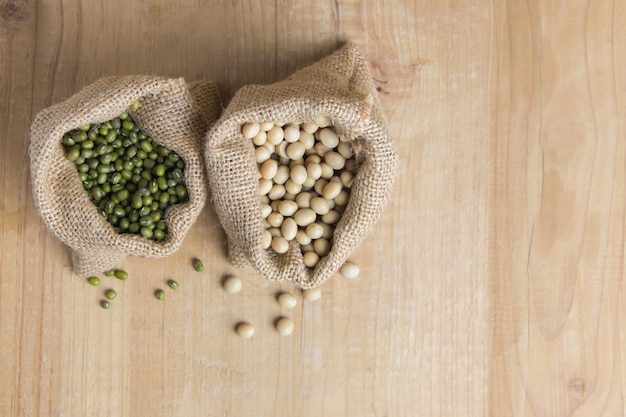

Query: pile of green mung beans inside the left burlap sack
[[62, 100, 188, 241]]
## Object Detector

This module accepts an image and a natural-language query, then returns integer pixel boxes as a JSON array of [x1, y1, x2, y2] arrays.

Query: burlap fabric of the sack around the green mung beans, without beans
[[29, 76, 221, 276]]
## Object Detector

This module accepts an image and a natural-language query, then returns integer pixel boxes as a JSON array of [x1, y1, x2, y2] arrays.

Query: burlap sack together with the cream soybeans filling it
[[204, 44, 398, 289]]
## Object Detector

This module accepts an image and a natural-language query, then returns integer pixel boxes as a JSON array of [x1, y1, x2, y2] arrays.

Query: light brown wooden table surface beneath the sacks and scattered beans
[[0, 0, 626, 417]]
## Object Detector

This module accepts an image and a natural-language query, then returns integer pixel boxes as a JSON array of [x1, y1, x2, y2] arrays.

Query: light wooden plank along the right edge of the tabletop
[[490, 1, 625, 416]]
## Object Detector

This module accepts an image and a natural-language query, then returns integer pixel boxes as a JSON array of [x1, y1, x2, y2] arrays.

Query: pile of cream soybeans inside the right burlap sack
[[242, 115, 357, 268]]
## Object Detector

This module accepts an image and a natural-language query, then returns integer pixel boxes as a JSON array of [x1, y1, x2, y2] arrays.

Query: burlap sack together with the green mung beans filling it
[[29, 76, 221, 276]]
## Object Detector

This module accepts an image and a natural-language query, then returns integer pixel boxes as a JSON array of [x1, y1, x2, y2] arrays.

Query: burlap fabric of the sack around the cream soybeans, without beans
[[204, 44, 398, 288]]
